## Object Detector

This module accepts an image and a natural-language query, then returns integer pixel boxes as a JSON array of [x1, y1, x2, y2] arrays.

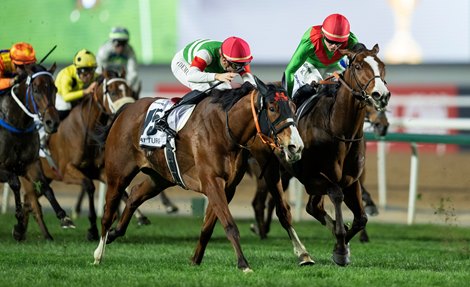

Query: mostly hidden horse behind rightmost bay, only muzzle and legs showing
[[252, 106, 390, 242]]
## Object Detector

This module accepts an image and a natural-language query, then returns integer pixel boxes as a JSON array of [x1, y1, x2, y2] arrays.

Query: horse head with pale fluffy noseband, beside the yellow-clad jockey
[[93, 70, 135, 114]]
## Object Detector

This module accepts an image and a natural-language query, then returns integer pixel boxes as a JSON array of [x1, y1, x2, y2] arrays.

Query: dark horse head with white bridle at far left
[[16, 63, 60, 133]]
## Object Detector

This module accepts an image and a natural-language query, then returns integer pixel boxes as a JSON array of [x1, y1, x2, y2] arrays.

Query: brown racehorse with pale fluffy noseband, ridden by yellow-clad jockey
[[21, 70, 135, 240]]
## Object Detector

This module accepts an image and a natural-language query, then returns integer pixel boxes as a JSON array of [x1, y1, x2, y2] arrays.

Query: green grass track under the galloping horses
[[0, 214, 470, 287]]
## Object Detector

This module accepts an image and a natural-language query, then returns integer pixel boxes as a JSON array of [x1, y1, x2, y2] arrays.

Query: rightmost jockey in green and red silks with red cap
[[284, 14, 358, 102]]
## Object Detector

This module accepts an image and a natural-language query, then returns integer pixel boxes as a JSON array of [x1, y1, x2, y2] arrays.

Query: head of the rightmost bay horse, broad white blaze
[[340, 43, 390, 111]]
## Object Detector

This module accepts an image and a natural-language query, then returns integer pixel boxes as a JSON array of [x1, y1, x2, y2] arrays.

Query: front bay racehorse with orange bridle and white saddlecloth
[[94, 80, 312, 272]]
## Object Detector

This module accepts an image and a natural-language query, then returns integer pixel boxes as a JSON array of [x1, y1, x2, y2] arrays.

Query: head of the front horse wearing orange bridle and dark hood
[[255, 77, 304, 163]]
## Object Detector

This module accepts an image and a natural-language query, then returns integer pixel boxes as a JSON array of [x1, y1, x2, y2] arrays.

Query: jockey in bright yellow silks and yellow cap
[[55, 49, 98, 120]]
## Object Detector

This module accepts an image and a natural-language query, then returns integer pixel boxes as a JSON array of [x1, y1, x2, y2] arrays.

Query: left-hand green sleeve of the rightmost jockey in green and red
[[284, 29, 315, 96]]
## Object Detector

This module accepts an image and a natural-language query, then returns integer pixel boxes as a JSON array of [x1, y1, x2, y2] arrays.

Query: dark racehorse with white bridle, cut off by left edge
[[0, 63, 60, 241]]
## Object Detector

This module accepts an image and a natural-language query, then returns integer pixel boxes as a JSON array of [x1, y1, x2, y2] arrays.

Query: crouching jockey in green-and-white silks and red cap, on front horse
[[171, 37, 255, 91]]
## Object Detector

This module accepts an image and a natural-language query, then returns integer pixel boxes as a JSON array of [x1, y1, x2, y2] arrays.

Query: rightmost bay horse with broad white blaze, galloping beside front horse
[[284, 44, 390, 266]]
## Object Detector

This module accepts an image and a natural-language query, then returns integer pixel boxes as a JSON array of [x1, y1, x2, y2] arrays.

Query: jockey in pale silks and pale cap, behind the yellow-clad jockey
[[96, 27, 141, 96]]
